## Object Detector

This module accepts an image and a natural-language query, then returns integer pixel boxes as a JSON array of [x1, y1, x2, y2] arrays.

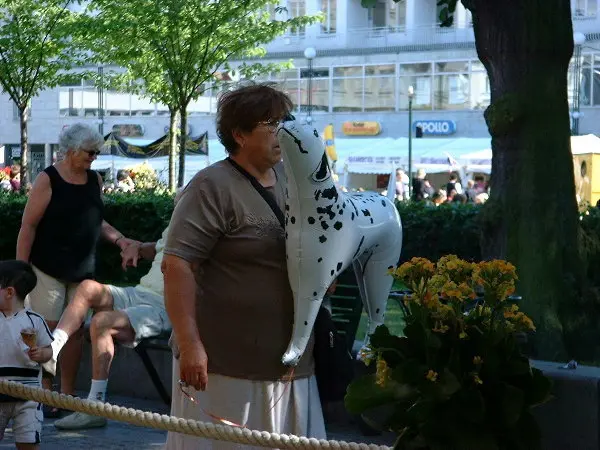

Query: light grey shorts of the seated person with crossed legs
[[108, 285, 171, 347]]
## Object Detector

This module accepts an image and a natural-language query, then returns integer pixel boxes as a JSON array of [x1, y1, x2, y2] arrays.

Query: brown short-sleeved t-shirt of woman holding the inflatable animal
[[164, 161, 314, 381]]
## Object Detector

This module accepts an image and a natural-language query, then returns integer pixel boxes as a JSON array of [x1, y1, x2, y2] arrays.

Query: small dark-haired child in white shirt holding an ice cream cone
[[0, 260, 53, 450]]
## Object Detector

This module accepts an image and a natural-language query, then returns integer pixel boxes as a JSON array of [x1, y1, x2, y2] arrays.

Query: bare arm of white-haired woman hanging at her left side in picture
[[17, 172, 52, 262]]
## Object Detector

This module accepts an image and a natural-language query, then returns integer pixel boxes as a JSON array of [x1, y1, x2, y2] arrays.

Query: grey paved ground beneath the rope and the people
[[0, 397, 393, 450]]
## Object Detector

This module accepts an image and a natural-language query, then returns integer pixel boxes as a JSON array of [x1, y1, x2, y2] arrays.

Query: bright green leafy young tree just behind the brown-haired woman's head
[[86, 0, 321, 189]]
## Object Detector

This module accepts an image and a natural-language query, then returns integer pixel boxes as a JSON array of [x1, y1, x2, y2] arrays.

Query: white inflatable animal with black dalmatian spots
[[277, 116, 402, 366]]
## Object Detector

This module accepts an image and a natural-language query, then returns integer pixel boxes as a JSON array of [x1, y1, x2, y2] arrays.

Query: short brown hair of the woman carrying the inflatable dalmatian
[[217, 83, 294, 154]]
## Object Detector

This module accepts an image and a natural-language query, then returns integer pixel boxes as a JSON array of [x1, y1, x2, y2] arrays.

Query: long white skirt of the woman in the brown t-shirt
[[166, 358, 326, 450]]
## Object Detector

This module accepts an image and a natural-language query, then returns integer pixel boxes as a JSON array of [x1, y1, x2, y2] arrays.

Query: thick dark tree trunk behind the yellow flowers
[[472, 0, 584, 360]]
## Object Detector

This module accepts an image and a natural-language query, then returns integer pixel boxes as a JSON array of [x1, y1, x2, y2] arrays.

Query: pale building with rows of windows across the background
[[0, 0, 600, 170]]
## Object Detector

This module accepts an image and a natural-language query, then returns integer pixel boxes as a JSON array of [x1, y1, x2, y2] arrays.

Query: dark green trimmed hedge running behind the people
[[0, 193, 600, 286]]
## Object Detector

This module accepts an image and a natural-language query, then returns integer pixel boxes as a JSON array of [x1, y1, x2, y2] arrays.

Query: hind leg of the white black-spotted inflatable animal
[[352, 252, 397, 357]]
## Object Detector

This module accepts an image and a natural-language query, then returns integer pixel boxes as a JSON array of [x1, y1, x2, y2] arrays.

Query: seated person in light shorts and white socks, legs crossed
[[43, 228, 171, 430]]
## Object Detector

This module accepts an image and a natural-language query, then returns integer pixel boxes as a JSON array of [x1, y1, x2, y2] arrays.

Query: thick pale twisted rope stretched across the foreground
[[0, 380, 391, 450]]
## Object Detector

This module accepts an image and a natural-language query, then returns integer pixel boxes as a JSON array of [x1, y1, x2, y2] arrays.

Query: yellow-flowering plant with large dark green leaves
[[345, 256, 551, 450]]
